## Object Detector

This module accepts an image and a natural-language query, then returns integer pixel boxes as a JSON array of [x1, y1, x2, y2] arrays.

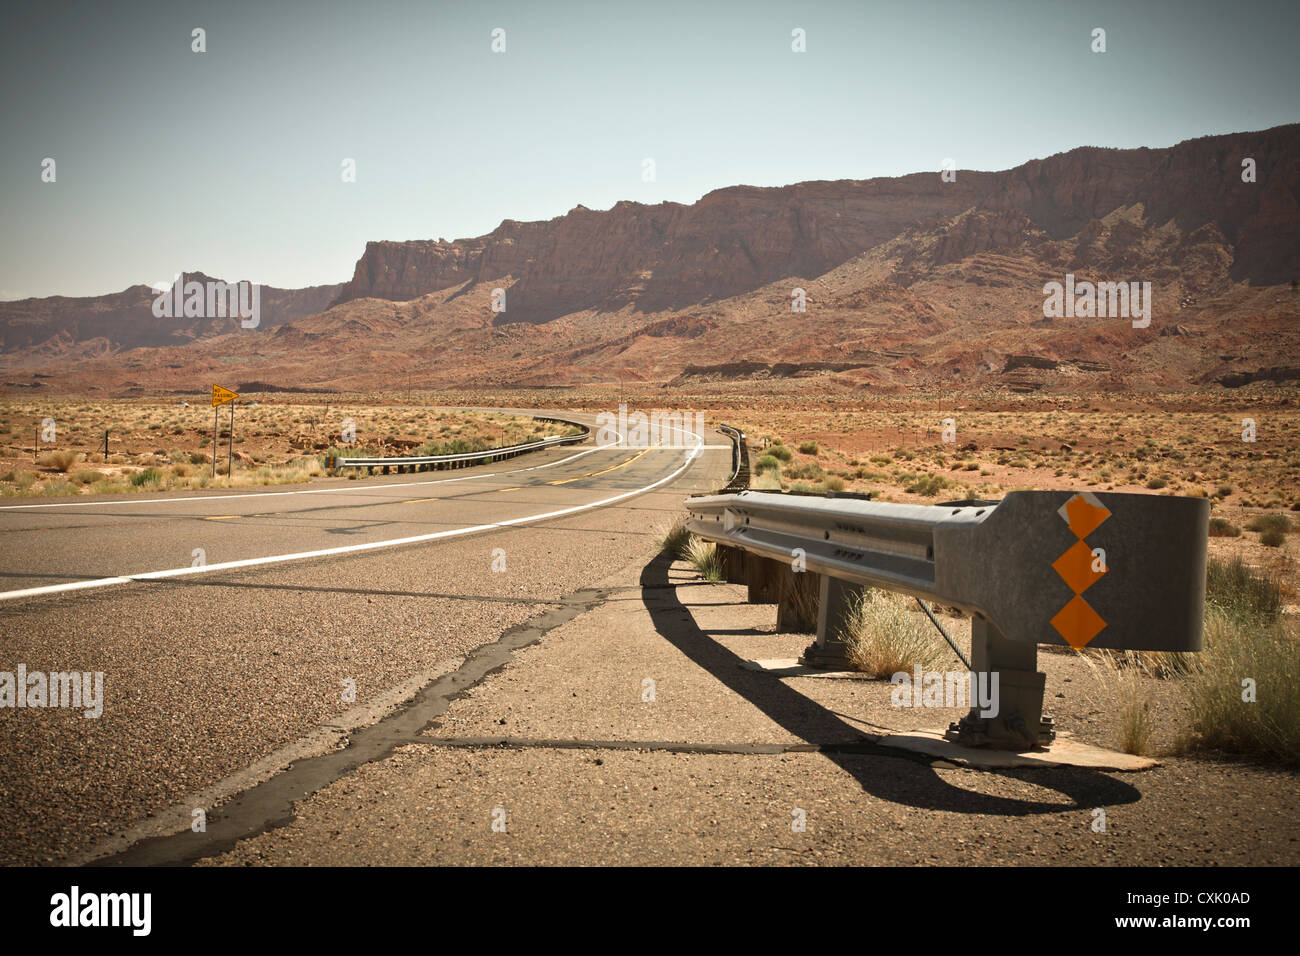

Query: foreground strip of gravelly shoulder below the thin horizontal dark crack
[[202, 747, 1300, 866]]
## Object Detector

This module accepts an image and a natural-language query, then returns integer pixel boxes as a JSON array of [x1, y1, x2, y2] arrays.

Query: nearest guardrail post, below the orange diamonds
[[945, 617, 1056, 749]]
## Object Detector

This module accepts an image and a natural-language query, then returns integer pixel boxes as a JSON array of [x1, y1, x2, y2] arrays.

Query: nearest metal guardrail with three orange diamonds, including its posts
[[686, 492, 1209, 747]]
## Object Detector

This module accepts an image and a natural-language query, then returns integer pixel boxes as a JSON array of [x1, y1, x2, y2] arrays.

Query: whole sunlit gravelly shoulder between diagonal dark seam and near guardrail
[[208, 554, 1300, 866]]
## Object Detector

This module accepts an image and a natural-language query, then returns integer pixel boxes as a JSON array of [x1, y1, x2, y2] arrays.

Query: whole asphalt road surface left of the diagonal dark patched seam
[[0, 415, 731, 864]]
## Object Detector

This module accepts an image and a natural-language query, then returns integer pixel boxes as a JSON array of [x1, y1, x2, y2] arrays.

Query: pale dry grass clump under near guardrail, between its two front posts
[[840, 589, 946, 678]]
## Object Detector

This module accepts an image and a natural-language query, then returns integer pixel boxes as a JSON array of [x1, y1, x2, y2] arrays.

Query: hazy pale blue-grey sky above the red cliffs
[[0, 0, 1300, 299]]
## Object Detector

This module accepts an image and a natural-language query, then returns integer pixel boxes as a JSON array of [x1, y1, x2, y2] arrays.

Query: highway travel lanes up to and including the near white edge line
[[0, 416, 703, 601]]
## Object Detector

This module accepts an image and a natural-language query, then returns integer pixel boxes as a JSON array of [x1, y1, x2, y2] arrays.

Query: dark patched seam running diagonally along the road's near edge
[[91, 588, 610, 866]]
